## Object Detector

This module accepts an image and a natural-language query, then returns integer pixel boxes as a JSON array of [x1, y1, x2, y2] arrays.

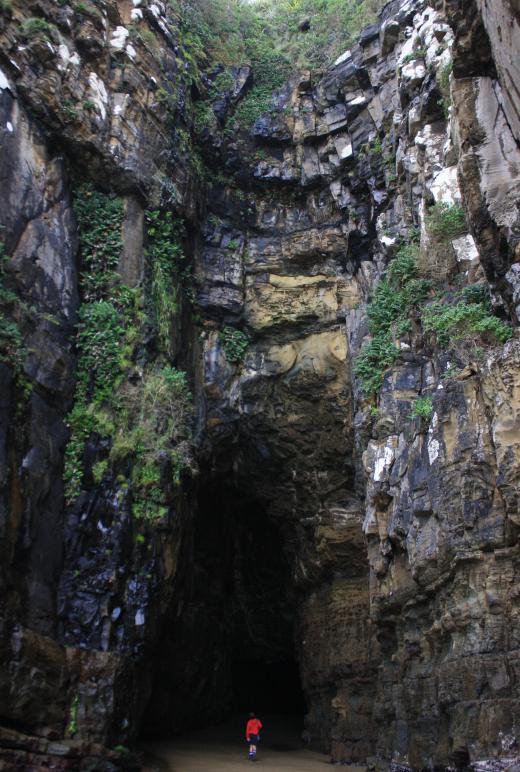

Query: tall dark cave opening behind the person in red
[[143, 483, 306, 738]]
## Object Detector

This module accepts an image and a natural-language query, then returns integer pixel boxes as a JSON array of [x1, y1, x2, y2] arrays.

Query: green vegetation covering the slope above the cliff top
[[183, 0, 383, 131]]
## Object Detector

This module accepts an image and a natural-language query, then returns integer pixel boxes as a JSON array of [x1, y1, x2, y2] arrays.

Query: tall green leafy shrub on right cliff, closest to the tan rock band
[[354, 244, 430, 397]]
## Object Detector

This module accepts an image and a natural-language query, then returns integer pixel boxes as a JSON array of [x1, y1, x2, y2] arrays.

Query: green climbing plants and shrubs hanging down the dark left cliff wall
[[64, 185, 191, 520]]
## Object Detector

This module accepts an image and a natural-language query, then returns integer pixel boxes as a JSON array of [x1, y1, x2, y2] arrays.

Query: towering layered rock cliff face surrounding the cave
[[0, 0, 520, 769]]
